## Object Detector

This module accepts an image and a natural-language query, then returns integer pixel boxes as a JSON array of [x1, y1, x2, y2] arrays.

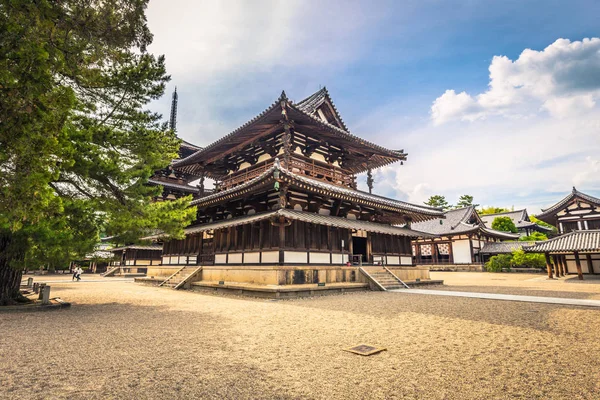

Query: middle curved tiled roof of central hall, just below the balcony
[[191, 160, 444, 219]]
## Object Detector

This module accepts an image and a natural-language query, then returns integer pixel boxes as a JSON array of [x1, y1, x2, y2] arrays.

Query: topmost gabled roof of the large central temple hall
[[173, 89, 406, 179]]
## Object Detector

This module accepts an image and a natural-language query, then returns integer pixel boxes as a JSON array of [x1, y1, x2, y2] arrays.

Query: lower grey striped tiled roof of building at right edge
[[523, 229, 600, 253]]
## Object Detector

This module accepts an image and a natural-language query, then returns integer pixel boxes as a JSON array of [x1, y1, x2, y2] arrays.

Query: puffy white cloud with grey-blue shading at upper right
[[431, 38, 600, 125]]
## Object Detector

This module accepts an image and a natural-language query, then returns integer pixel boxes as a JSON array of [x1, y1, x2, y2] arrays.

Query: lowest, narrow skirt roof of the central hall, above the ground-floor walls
[[144, 209, 432, 240]]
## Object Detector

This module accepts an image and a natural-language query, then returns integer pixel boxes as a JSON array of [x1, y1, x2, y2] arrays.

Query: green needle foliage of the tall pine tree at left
[[0, 0, 195, 300]]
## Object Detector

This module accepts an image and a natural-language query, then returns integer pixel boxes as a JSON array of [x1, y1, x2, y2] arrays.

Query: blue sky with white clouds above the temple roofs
[[148, 0, 600, 213]]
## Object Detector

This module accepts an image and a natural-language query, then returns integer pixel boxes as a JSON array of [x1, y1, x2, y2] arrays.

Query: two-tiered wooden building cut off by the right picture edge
[[524, 187, 600, 279]]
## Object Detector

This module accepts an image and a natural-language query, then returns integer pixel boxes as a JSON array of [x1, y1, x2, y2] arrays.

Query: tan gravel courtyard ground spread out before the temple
[[0, 274, 600, 399]]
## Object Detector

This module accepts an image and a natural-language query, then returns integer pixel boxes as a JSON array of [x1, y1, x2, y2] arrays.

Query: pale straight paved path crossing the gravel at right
[[390, 289, 600, 307]]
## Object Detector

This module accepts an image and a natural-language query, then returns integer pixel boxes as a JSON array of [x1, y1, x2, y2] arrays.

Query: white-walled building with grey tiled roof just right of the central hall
[[412, 206, 519, 271]]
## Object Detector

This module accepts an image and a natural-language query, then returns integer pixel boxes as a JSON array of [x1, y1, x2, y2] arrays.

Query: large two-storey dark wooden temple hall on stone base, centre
[[139, 88, 443, 294]]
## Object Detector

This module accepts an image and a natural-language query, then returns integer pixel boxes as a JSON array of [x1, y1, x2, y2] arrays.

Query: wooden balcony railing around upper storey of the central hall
[[216, 157, 354, 191]]
